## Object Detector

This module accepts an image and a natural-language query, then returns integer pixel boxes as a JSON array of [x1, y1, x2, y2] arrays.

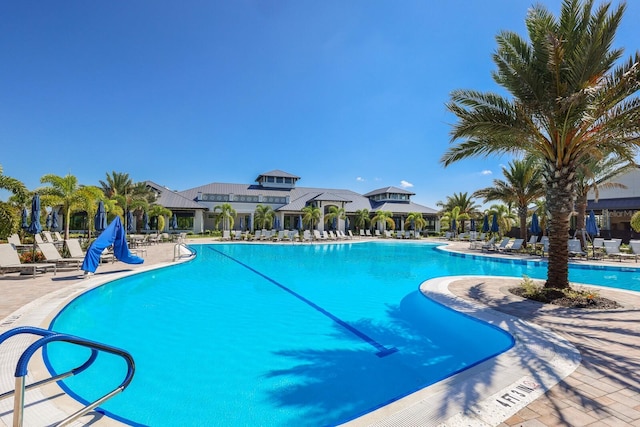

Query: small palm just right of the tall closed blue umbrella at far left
[[39, 174, 85, 240]]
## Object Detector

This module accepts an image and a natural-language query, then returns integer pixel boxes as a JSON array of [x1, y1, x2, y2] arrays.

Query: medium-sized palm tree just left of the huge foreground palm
[[473, 156, 544, 246]]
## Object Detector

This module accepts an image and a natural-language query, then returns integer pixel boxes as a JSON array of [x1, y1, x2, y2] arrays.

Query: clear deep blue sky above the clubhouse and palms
[[0, 0, 640, 208]]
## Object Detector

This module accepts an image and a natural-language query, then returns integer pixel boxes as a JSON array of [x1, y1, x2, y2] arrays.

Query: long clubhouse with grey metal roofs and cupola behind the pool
[[147, 170, 440, 234]]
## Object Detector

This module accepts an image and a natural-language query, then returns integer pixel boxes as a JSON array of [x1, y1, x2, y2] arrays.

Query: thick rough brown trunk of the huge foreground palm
[[544, 165, 575, 289]]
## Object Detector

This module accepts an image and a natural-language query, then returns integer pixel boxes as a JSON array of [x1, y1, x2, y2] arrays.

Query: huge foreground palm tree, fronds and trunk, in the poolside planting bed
[[441, 0, 640, 288]]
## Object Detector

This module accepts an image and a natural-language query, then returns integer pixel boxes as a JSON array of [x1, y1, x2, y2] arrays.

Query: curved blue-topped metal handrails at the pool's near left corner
[[0, 326, 135, 427]]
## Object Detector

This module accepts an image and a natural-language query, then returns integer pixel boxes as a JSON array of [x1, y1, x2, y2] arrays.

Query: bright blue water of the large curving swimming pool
[[46, 242, 638, 426]]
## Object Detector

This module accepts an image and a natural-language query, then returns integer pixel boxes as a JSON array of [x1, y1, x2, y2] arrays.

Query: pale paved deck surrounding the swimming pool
[[0, 239, 640, 427]]
